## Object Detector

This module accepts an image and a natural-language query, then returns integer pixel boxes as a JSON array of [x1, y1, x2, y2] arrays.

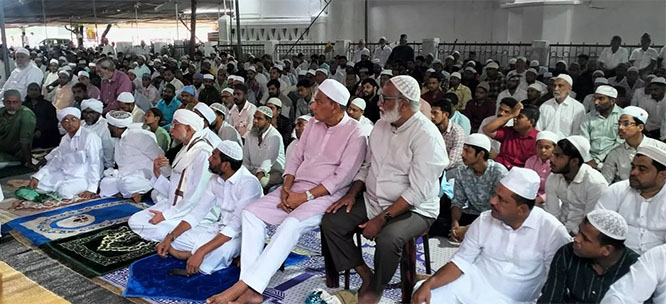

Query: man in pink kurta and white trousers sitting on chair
[[207, 79, 366, 304]]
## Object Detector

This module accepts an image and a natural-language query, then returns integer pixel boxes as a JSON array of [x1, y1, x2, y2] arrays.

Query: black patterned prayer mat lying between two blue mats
[[40, 223, 157, 277]]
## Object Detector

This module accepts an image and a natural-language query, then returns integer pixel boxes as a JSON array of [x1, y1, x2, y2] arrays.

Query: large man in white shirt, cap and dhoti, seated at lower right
[[412, 167, 571, 303]]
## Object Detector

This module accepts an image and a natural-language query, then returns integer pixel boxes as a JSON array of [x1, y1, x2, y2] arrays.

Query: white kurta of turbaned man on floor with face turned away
[[100, 128, 163, 198]]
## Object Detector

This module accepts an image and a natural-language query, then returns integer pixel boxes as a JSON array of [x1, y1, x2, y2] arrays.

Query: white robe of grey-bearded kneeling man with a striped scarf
[[128, 132, 213, 242]]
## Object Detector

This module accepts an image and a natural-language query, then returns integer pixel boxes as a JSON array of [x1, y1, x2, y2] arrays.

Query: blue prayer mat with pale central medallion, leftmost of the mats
[[7, 198, 143, 246]]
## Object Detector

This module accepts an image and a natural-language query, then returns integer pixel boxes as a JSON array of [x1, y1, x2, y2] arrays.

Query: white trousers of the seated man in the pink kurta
[[240, 210, 323, 293]]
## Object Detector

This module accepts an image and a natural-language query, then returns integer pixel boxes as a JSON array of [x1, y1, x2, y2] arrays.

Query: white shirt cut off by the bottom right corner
[[601, 245, 666, 304]]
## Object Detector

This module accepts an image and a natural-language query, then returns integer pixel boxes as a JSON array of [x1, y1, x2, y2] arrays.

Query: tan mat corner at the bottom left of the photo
[[0, 262, 69, 304]]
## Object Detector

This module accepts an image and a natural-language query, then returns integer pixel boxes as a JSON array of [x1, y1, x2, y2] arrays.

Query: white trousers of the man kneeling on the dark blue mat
[[171, 223, 241, 274]]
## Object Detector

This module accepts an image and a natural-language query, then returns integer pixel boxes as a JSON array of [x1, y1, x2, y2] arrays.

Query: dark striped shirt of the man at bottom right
[[538, 243, 639, 303]]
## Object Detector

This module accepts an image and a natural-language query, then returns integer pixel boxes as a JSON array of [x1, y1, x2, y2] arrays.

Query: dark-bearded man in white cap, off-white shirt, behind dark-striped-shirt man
[[544, 135, 608, 235]]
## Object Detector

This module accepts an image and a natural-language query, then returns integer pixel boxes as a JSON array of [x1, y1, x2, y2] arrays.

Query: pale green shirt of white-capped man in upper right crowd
[[580, 105, 622, 163]]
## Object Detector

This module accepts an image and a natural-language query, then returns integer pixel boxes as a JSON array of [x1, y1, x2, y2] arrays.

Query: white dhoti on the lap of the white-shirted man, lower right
[[414, 265, 510, 304]]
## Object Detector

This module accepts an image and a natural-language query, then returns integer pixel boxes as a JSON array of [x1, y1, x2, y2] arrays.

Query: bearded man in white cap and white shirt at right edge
[[597, 146, 666, 254]]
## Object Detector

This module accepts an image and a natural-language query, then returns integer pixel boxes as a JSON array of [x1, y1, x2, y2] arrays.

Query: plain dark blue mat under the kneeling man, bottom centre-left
[[123, 253, 307, 301]]
